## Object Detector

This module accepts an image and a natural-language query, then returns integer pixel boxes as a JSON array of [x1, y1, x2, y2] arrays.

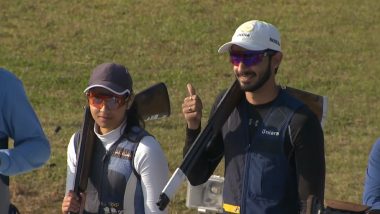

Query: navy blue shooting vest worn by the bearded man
[[222, 90, 304, 214]]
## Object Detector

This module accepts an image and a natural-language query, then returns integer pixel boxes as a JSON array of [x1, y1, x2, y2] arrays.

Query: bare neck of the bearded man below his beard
[[245, 84, 279, 105]]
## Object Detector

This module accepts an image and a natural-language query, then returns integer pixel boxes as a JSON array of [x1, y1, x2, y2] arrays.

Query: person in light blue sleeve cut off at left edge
[[0, 68, 50, 213]]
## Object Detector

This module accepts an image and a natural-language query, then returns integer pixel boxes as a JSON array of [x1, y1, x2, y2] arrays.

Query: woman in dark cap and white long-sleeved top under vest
[[62, 63, 169, 213]]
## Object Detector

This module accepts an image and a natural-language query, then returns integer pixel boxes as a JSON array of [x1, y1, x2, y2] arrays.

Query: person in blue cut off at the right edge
[[363, 138, 380, 210]]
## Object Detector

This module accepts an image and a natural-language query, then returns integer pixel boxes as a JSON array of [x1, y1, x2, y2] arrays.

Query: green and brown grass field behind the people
[[0, 0, 380, 213]]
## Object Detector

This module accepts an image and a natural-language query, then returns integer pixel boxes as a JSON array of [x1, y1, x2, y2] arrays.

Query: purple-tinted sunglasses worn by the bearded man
[[230, 51, 275, 67]]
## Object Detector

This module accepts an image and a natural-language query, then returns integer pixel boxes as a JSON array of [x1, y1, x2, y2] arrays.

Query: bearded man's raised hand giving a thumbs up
[[182, 83, 203, 129]]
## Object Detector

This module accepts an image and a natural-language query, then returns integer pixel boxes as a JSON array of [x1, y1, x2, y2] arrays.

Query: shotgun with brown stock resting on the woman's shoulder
[[70, 83, 170, 213]]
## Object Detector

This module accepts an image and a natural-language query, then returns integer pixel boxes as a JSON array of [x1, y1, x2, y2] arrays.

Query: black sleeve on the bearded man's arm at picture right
[[285, 107, 325, 209]]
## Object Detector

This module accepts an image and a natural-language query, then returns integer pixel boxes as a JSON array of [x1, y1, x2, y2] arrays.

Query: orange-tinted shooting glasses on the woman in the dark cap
[[87, 91, 128, 110]]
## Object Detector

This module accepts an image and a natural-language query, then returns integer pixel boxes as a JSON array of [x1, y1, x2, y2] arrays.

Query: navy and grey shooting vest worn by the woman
[[74, 127, 149, 214]]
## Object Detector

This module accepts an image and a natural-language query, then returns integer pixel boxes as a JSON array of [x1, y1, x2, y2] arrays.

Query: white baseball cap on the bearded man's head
[[218, 20, 281, 53]]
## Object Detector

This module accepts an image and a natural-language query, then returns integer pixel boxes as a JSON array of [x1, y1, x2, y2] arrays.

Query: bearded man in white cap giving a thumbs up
[[182, 20, 325, 214]]
